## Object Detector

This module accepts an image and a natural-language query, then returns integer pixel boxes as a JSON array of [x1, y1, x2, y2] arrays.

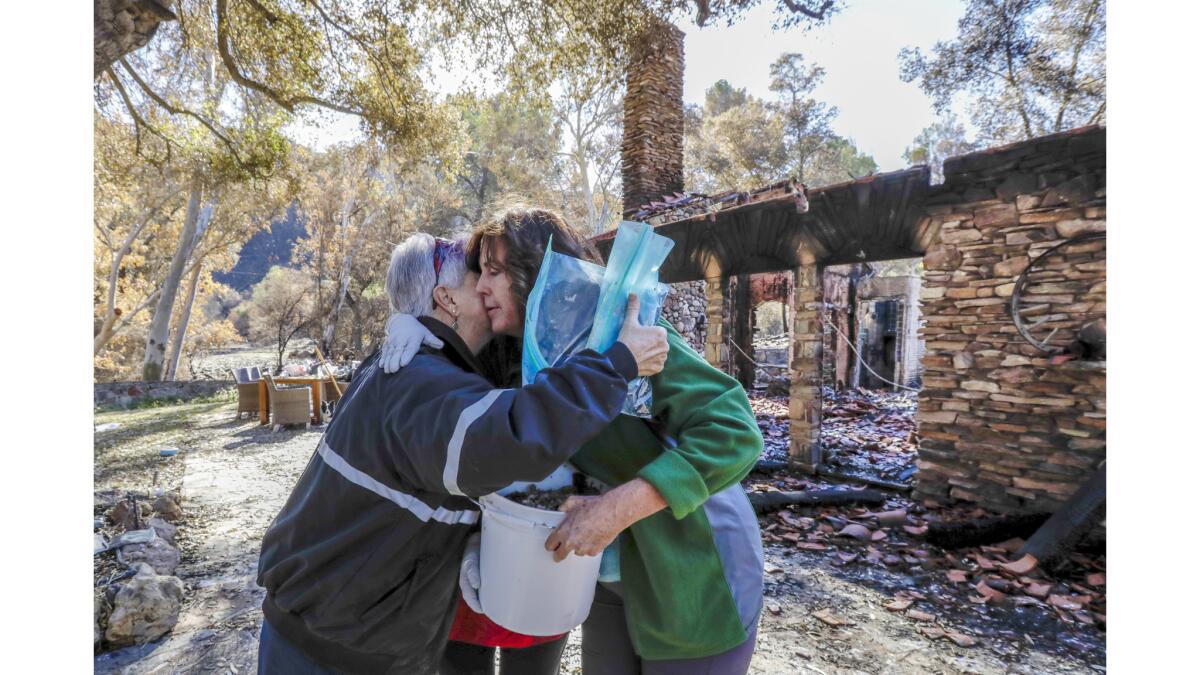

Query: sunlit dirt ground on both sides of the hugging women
[[95, 402, 1105, 675]]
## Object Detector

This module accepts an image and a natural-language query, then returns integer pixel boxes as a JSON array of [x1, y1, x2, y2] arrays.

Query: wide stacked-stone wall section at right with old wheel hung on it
[[916, 127, 1106, 512]]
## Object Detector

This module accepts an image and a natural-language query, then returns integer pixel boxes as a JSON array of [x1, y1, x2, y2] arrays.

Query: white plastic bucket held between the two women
[[479, 495, 600, 635]]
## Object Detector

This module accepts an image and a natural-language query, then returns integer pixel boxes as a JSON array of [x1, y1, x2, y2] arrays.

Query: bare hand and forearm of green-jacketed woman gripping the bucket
[[546, 478, 667, 562]]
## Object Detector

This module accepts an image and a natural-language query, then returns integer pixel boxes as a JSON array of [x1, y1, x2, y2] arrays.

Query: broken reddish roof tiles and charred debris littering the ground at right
[[743, 474, 1106, 646]]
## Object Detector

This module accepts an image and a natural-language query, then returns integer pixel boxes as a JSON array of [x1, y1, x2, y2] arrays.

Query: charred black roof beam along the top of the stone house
[[594, 126, 1104, 283]]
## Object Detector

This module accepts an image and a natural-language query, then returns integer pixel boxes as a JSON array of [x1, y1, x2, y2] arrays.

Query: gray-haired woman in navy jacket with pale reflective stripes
[[258, 234, 667, 674]]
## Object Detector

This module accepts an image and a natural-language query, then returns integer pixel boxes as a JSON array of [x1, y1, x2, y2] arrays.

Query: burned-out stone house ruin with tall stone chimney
[[595, 26, 1106, 512]]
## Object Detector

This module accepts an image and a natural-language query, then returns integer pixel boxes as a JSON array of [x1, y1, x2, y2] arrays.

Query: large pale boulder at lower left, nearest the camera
[[104, 563, 184, 645]]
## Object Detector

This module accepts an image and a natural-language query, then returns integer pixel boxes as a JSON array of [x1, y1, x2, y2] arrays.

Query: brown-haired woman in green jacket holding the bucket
[[384, 208, 763, 675]]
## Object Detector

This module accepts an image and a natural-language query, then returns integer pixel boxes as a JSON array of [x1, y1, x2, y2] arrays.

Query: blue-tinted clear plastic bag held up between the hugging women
[[521, 221, 674, 417]]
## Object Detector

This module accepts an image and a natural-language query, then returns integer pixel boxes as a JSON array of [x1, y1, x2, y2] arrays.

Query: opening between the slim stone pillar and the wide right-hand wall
[[821, 258, 924, 485]]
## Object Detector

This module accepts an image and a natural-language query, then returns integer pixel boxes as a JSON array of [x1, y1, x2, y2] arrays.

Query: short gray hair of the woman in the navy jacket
[[388, 232, 467, 316]]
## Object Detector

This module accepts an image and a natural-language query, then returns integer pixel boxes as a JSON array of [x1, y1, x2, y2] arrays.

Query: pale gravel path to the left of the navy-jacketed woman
[[95, 404, 320, 674]]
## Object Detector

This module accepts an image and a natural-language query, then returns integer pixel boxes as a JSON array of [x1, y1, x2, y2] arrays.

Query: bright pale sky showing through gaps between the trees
[[290, 0, 970, 171]]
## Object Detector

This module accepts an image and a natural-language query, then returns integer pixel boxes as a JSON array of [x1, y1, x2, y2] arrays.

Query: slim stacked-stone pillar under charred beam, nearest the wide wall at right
[[788, 264, 824, 471]]
